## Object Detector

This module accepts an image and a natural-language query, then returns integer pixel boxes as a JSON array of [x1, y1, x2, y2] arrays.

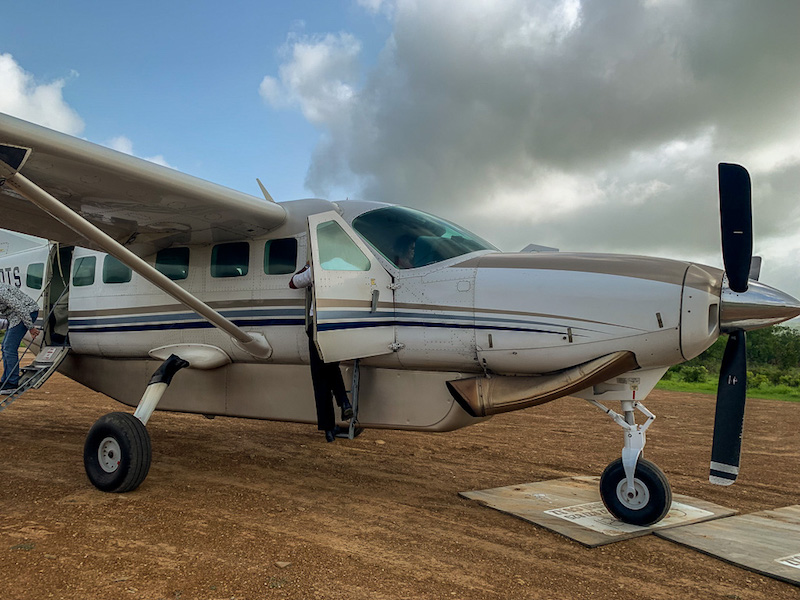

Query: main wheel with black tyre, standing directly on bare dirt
[[83, 412, 152, 493]]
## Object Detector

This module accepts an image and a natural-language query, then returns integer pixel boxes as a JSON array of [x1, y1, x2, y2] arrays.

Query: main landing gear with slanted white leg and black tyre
[[83, 354, 189, 493]]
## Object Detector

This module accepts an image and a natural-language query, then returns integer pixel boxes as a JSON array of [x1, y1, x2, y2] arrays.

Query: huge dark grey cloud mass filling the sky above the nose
[[262, 0, 800, 287]]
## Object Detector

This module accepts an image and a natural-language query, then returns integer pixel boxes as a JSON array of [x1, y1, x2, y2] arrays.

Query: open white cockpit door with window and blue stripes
[[308, 211, 395, 362]]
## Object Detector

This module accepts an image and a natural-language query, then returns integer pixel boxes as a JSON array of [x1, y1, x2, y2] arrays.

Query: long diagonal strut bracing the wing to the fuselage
[[0, 160, 272, 359]]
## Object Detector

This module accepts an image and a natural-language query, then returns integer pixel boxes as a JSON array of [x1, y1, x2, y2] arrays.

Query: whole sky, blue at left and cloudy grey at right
[[0, 0, 800, 297]]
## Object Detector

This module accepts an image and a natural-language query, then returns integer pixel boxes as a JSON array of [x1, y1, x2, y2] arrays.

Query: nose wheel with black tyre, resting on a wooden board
[[600, 458, 672, 527]]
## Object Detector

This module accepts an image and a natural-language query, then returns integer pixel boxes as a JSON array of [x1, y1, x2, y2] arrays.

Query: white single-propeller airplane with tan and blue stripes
[[0, 114, 800, 525]]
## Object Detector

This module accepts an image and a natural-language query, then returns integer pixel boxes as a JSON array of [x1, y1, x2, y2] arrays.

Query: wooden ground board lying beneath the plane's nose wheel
[[460, 477, 736, 548]]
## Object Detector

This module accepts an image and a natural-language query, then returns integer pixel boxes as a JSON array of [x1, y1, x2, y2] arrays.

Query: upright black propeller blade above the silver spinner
[[719, 163, 753, 293]]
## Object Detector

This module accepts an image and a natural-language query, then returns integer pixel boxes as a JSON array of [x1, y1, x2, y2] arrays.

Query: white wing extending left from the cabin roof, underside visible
[[0, 113, 286, 256]]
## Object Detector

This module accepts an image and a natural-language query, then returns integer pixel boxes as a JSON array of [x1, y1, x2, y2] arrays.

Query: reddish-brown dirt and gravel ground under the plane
[[0, 375, 800, 600]]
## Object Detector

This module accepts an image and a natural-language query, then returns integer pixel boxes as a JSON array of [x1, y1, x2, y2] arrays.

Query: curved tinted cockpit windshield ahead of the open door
[[353, 206, 497, 269]]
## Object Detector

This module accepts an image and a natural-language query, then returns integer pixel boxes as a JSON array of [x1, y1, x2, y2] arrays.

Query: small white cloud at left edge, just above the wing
[[0, 54, 84, 135]]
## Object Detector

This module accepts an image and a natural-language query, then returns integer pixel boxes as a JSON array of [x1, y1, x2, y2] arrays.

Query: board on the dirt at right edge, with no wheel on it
[[656, 505, 800, 586]]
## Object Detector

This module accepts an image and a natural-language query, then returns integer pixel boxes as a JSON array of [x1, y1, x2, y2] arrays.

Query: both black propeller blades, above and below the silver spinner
[[709, 163, 753, 485]]
